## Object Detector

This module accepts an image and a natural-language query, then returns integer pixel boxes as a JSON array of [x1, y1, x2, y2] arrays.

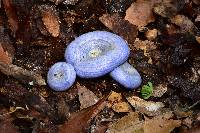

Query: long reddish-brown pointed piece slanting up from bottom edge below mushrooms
[[59, 97, 106, 133]]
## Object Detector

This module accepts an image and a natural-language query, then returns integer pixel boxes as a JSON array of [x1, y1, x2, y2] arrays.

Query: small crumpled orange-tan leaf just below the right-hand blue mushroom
[[108, 91, 132, 113]]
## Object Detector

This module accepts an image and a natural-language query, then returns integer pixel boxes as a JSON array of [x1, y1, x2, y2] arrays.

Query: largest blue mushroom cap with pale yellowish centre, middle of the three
[[65, 31, 130, 78]]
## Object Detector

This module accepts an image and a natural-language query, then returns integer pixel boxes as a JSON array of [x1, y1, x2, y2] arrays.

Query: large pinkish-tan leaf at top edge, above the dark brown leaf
[[125, 0, 159, 27]]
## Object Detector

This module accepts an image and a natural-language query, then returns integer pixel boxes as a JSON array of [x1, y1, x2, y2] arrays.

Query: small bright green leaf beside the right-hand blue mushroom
[[140, 82, 153, 99]]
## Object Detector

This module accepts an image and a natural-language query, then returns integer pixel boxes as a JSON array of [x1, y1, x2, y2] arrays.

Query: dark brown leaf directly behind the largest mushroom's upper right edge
[[99, 14, 137, 44]]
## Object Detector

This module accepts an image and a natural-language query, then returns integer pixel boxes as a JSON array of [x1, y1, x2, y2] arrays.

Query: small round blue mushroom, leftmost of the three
[[47, 62, 76, 91]]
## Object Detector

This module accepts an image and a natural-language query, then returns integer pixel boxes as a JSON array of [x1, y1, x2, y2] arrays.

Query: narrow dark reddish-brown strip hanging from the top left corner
[[2, 0, 19, 37]]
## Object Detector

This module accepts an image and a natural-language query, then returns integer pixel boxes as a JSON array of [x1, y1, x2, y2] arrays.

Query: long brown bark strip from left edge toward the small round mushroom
[[0, 62, 46, 86]]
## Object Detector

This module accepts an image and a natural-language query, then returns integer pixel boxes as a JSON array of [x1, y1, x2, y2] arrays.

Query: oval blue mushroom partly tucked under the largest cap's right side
[[110, 62, 142, 90]]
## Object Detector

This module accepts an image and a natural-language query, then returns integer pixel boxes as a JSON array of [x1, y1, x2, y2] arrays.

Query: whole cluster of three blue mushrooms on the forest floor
[[47, 31, 142, 91]]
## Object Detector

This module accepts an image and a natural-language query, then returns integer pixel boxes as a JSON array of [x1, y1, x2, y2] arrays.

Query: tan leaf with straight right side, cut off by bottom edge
[[107, 112, 143, 133]]
